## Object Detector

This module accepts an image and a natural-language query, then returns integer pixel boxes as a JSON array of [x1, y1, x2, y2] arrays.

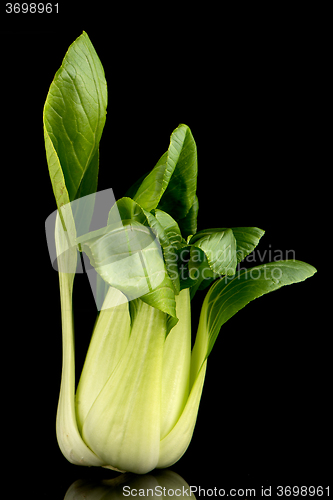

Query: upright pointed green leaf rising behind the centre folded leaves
[[128, 125, 198, 221]]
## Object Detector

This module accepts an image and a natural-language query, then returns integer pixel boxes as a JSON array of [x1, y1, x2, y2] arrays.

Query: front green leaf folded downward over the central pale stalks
[[78, 221, 176, 317]]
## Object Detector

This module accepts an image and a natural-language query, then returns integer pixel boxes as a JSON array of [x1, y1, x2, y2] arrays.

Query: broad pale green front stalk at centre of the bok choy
[[82, 301, 166, 474]]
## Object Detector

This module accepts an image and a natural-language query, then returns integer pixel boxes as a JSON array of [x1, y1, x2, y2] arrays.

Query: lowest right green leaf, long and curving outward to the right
[[193, 260, 316, 375]]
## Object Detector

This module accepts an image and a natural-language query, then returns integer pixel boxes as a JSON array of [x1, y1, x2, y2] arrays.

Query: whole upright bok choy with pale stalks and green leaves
[[44, 33, 315, 473]]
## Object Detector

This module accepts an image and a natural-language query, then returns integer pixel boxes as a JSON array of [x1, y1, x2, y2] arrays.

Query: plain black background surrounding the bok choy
[[1, 3, 332, 499]]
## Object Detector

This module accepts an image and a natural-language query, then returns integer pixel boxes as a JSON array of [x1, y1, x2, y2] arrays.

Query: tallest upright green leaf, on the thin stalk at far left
[[43, 32, 107, 212]]
